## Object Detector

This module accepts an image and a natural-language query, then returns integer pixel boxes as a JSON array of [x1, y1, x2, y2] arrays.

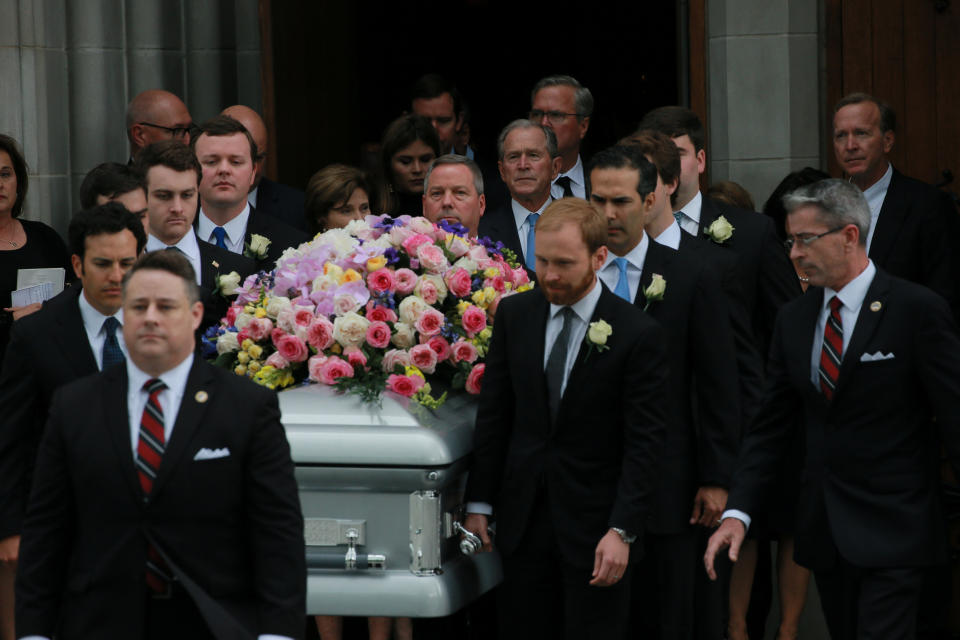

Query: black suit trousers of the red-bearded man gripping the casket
[[498, 492, 632, 640]]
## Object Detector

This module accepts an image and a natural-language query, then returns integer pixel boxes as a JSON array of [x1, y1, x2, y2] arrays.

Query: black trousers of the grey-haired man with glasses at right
[[813, 556, 924, 640]]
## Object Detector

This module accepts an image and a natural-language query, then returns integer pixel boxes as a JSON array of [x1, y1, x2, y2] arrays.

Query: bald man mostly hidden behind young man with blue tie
[[221, 104, 307, 231]]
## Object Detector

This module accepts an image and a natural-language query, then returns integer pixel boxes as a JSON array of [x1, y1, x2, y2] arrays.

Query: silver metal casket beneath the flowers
[[279, 385, 502, 618]]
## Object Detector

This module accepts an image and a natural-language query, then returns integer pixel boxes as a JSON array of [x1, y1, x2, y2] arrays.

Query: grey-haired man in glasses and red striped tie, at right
[[704, 180, 960, 639]]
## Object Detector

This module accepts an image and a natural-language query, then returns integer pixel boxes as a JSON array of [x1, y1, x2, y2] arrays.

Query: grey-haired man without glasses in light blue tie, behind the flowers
[[478, 120, 560, 279]]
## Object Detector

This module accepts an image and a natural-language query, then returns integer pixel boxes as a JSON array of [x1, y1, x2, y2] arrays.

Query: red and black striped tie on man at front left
[[137, 378, 172, 594]]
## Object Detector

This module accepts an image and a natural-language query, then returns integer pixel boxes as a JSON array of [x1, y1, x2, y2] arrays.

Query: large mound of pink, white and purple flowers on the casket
[[203, 215, 533, 407]]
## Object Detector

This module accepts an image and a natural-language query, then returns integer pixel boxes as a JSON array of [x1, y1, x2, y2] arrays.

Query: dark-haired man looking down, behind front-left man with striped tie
[[0, 203, 146, 562]]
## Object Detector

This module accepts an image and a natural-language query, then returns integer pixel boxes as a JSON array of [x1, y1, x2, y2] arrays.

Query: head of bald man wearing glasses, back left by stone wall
[[127, 89, 193, 160]]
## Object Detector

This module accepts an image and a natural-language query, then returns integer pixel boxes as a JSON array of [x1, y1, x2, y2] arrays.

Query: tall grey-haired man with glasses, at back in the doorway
[[530, 76, 593, 199]]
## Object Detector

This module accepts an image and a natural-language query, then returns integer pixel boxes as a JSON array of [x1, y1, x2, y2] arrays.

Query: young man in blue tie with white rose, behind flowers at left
[[191, 116, 309, 271]]
